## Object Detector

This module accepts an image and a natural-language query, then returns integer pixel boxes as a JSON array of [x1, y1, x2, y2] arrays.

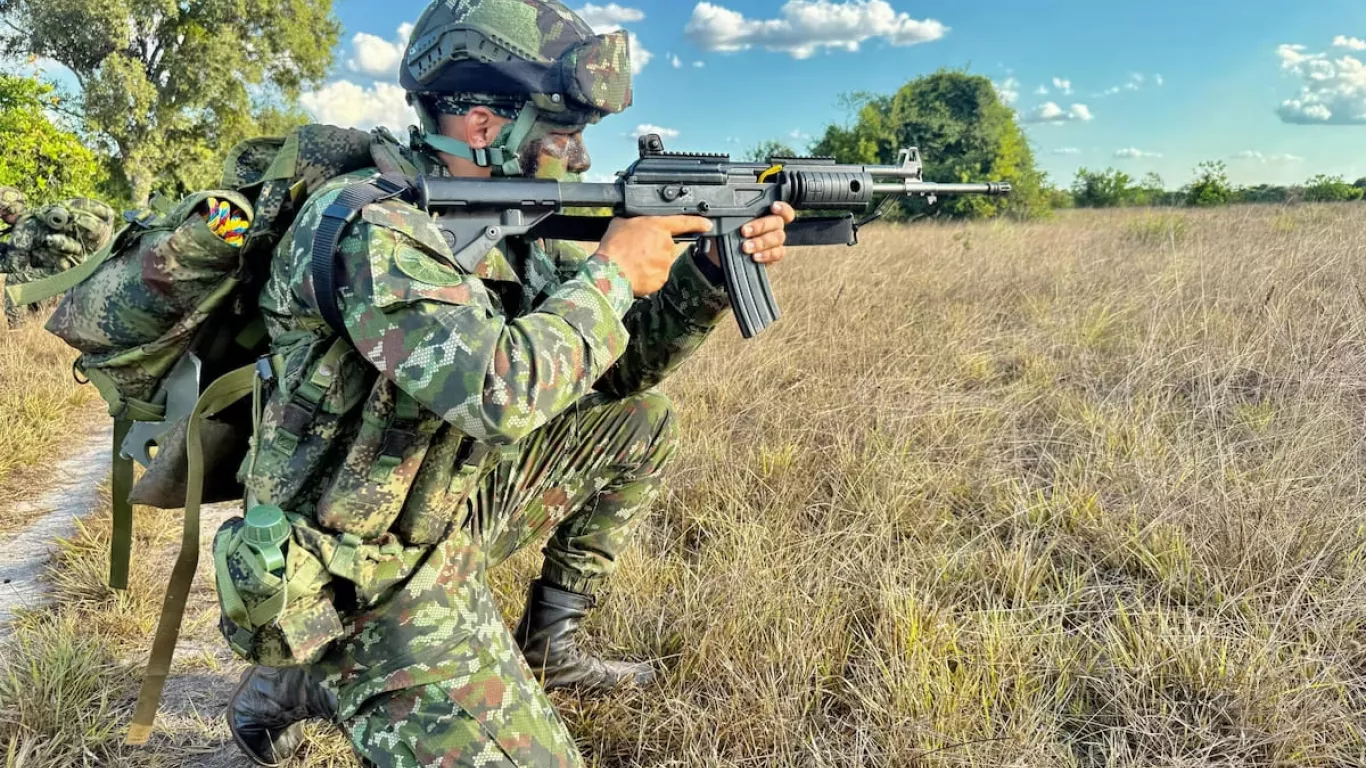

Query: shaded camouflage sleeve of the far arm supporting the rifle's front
[[596, 249, 731, 398]]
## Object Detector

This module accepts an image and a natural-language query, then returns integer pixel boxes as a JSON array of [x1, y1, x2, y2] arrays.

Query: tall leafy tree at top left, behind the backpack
[[0, 0, 340, 205]]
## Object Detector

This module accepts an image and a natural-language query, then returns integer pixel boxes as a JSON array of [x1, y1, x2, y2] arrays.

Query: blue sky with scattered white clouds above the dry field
[[224, 0, 1366, 187]]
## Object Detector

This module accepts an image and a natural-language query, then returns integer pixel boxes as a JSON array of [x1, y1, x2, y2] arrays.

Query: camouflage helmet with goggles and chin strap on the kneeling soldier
[[399, 0, 631, 176]]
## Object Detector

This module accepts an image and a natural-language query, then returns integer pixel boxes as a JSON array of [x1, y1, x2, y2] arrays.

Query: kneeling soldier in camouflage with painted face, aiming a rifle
[[227, 0, 794, 768]]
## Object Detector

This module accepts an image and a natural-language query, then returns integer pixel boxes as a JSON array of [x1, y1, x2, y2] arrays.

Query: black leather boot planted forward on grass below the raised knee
[[515, 579, 654, 693]]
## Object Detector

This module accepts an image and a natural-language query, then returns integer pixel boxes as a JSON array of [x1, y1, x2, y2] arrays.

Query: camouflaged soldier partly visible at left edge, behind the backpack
[[0, 194, 115, 324]]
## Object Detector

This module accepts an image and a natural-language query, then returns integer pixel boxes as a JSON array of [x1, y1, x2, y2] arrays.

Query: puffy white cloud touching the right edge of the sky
[[1276, 41, 1366, 126]]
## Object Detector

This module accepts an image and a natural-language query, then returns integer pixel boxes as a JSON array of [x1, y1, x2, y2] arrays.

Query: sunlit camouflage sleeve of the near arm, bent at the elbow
[[330, 202, 632, 444]]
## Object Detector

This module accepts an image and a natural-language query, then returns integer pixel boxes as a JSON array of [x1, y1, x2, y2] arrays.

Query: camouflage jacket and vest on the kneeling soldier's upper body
[[246, 166, 729, 535]]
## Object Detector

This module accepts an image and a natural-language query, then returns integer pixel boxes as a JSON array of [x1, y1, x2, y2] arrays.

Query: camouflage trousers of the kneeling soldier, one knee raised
[[321, 391, 675, 768]]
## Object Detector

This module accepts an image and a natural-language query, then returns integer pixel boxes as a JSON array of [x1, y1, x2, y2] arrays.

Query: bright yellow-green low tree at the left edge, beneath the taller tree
[[0, 74, 102, 204]]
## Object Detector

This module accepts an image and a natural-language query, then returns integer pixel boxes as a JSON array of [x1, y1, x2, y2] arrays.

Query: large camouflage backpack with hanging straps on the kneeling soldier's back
[[30, 124, 406, 745]]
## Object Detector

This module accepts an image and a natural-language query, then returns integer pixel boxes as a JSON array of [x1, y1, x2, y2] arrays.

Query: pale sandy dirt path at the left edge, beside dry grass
[[0, 421, 113, 628]]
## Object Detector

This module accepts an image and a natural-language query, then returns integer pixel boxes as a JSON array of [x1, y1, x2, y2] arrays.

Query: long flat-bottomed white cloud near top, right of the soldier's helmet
[[683, 0, 948, 59]]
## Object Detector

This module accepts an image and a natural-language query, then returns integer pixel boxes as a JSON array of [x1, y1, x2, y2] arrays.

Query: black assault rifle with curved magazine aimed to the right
[[316, 134, 1011, 339]]
